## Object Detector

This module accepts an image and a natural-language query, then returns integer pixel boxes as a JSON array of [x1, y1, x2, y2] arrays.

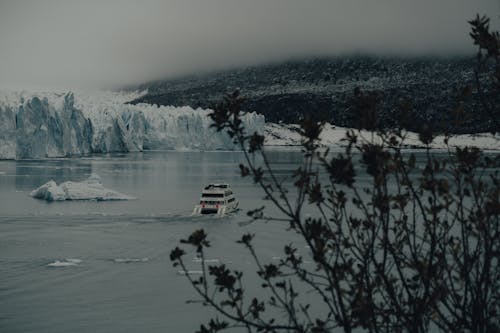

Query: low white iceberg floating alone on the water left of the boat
[[30, 174, 135, 201]]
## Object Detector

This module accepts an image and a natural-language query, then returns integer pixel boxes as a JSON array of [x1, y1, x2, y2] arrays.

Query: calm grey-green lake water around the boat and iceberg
[[0, 152, 299, 332]]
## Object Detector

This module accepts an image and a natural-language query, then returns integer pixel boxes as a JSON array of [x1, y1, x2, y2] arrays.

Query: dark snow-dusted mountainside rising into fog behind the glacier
[[131, 56, 494, 133]]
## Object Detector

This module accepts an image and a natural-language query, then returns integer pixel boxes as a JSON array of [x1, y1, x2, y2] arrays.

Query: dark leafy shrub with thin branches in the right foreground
[[170, 17, 500, 333]]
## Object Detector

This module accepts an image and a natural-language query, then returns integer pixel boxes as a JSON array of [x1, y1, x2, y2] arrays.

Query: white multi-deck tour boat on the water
[[193, 184, 238, 215]]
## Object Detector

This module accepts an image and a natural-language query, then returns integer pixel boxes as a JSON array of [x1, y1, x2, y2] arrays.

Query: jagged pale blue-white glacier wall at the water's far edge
[[0, 91, 265, 159]]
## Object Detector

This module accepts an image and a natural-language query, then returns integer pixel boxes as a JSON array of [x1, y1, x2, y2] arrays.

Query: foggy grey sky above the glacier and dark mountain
[[0, 0, 500, 88]]
